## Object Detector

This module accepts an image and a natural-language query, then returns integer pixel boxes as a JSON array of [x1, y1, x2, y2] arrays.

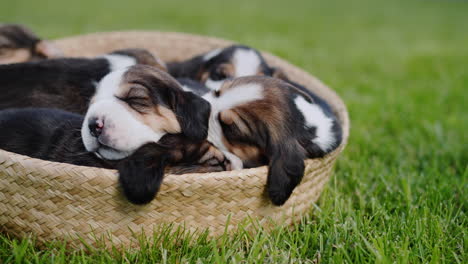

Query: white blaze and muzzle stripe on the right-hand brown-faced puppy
[[203, 84, 263, 170]]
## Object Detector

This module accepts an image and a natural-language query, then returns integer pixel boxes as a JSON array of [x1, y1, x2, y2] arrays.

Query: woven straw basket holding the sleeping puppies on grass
[[0, 32, 349, 249]]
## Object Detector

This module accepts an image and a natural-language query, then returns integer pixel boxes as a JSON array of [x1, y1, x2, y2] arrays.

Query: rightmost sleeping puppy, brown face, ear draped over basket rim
[[204, 76, 342, 205]]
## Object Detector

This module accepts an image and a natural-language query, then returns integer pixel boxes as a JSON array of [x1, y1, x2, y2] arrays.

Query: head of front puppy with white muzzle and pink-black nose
[[81, 65, 210, 160]]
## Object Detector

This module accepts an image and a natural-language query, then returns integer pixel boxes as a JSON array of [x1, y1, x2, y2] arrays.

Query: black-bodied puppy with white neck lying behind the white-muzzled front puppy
[[0, 49, 165, 114]]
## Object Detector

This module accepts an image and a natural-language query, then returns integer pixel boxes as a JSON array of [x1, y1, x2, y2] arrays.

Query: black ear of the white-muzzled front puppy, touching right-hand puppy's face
[[172, 91, 211, 141]]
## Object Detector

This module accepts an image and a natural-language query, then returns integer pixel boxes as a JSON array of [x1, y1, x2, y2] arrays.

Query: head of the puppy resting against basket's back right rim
[[189, 45, 285, 90]]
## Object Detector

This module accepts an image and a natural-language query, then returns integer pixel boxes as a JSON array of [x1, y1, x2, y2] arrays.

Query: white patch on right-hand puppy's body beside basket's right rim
[[294, 96, 335, 151]]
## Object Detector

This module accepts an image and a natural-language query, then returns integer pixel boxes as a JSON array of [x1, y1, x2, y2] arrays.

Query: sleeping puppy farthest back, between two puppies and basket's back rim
[[167, 45, 284, 90]]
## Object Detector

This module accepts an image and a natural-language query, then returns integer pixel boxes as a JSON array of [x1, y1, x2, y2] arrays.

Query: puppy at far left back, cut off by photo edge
[[0, 24, 63, 64]]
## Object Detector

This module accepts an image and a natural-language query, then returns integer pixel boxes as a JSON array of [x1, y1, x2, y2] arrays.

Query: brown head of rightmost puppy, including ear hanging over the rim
[[206, 76, 305, 205]]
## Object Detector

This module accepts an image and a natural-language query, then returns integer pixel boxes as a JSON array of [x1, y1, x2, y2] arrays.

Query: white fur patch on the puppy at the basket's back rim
[[233, 49, 261, 77]]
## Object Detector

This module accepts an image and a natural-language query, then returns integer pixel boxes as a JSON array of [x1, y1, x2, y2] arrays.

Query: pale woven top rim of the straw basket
[[0, 30, 349, 185]]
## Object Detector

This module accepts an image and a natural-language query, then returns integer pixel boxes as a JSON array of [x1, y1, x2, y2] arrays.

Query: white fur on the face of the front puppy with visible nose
[[81, 69, 166, 160]]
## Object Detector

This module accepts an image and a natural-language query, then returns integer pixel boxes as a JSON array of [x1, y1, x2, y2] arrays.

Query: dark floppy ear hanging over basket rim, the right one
[[267, 140, 305, 206]]
